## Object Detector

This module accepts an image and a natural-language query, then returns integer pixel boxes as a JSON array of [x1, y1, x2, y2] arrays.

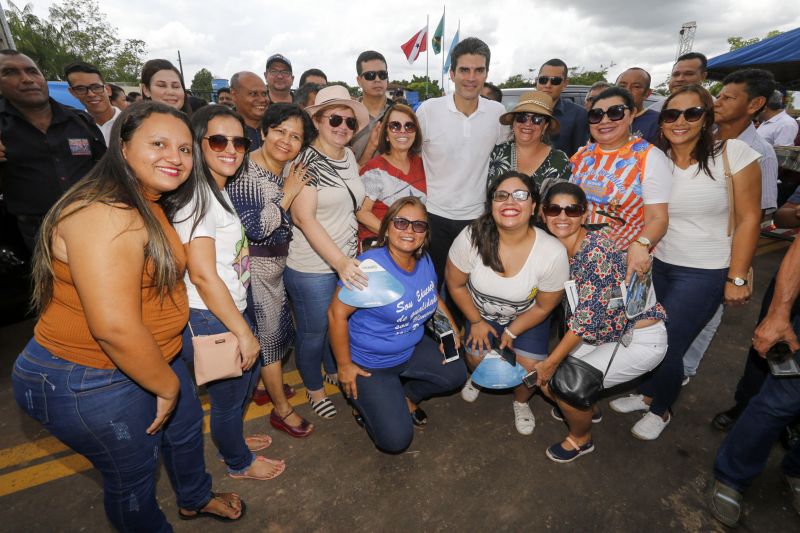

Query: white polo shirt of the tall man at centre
[[417, 95, 510, 220]]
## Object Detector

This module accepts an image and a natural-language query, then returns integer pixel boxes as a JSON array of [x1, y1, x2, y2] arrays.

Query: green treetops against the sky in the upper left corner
[[6, 0, 145, 82]]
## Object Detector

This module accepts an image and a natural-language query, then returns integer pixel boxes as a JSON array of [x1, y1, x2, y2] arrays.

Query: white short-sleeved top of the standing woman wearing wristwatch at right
[[655, 139, 760, 269]]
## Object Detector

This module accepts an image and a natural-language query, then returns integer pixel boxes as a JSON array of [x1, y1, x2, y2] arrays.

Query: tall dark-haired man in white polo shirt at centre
[[417, 37, 509, 288]]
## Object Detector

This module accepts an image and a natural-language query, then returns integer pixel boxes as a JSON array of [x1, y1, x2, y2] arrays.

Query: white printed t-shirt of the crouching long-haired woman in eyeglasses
[[449, 227, 569, 325]]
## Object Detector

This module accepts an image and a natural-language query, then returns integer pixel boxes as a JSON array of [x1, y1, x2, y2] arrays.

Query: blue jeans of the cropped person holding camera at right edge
[[714, 350, 800, 492]]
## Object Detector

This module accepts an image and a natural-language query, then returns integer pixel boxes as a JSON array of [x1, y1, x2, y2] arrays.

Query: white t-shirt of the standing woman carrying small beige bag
[[174, 190, 250, 311]]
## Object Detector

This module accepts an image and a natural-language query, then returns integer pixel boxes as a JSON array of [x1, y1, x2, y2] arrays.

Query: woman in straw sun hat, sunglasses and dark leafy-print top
[[489, 91, 570, 195]]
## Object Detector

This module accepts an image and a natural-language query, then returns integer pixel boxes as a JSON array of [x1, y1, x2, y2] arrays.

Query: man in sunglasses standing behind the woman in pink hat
[[350, 50, 392, 166]]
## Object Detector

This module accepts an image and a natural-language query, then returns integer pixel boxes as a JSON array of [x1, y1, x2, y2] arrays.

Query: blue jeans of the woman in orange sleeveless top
[[11, 339, 211, 532]]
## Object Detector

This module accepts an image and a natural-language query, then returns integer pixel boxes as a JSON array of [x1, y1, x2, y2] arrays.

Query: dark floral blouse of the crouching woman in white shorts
[[567, 231, 667, 346]]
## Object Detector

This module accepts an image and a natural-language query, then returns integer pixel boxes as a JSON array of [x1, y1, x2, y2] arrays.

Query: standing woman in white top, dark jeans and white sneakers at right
[[611, 85, 761, 440]]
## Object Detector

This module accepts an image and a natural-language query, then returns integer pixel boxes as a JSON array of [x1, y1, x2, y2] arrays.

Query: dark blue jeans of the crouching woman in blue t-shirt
[[352, 336, 467, 453]]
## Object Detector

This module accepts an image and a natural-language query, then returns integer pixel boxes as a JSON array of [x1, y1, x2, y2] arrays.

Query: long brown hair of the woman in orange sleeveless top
[[31, 101, 194, 313]]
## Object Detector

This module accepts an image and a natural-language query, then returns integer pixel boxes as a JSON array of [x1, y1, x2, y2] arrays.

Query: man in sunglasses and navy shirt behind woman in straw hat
[[536, 58, 589, 157]]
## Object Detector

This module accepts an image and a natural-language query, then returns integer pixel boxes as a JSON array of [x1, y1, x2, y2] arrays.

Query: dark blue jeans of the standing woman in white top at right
[[639, 259, 728, 416]]
